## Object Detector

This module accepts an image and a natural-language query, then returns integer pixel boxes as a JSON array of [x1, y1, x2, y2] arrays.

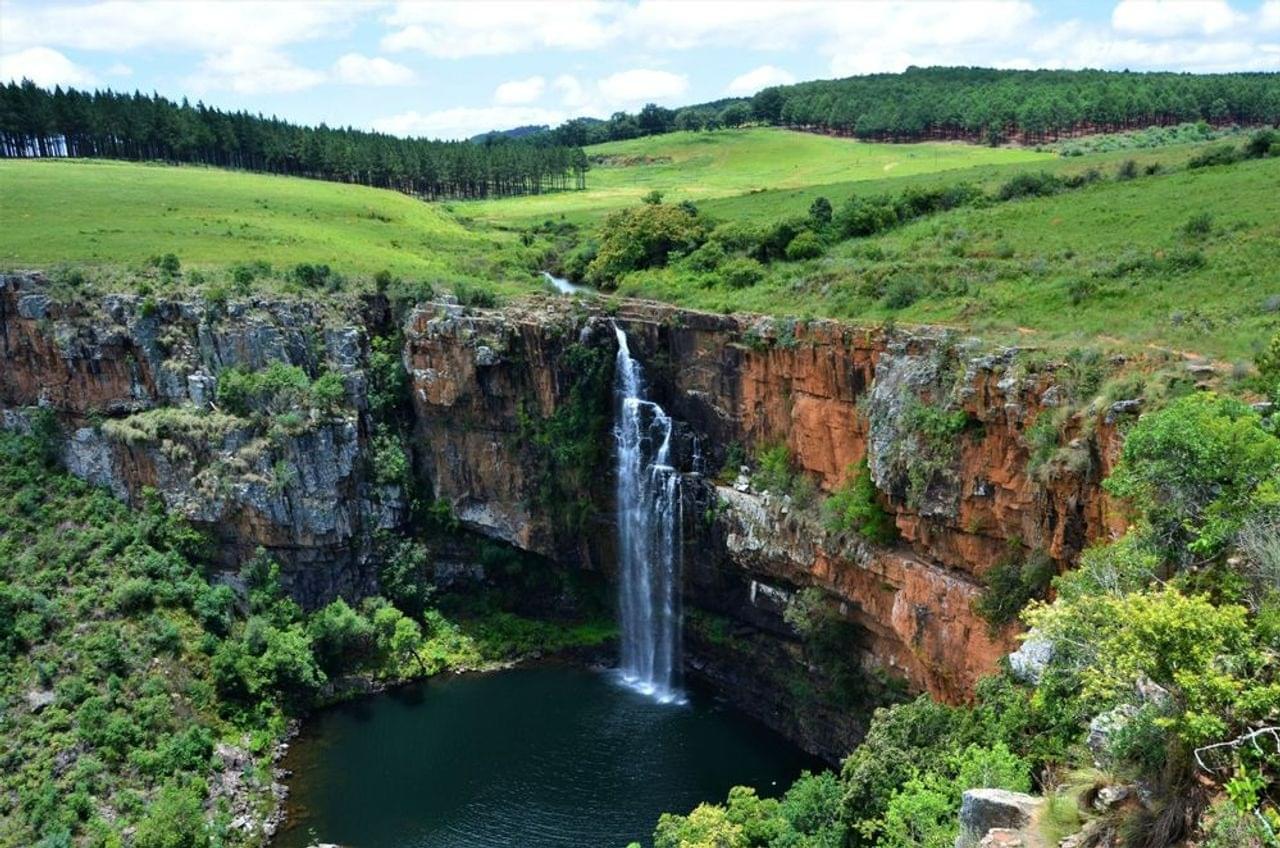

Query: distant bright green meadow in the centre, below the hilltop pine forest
[[454, 127, 1052, 225]]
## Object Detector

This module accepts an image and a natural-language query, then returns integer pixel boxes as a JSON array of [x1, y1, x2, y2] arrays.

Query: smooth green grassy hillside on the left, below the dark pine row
[[0, 160, 531, 294]]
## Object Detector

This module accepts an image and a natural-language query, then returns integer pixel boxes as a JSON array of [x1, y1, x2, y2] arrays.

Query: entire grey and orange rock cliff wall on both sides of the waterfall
[[0, 277, 1119, 756]]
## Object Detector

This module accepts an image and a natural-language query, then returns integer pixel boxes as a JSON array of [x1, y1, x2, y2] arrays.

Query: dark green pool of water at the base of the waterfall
[[274, 666, 820, 848]]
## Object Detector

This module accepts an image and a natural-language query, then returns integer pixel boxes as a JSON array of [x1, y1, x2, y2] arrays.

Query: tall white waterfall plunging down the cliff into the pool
[[613, 325, 684, 702]]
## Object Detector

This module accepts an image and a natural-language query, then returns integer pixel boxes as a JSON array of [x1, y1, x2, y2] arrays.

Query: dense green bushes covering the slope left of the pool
[[0, 432, 614, 848]]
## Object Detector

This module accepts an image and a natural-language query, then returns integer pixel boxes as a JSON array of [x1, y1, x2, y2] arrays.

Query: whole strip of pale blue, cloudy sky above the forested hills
[[0, 0, 1280, 137]]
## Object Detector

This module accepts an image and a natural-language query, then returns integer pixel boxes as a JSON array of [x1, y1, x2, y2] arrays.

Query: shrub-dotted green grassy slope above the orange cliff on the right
[[618, 153, 1280, 360]]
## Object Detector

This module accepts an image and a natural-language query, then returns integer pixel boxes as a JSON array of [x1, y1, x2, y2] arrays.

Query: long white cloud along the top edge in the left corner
[[4, 0, 371, 53]]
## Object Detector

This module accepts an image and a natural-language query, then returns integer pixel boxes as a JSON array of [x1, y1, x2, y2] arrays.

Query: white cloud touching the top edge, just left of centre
[[383, 0, 620, 59]]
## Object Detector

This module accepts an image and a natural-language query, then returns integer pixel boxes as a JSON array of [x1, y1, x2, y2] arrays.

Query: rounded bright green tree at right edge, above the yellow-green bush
[[1106, 393, 1280, 560]]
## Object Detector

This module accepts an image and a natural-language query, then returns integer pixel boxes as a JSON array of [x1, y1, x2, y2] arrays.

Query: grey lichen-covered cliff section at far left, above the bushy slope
[[0, 275, 404, 605]]
